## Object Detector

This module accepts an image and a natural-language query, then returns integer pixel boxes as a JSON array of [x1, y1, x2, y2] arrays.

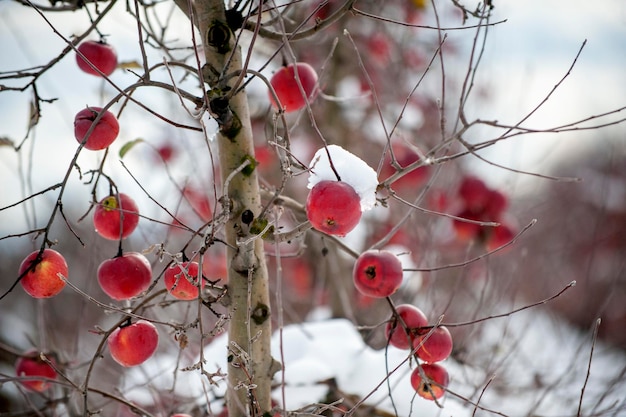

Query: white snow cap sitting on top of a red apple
[[308, 145, 378, 212]]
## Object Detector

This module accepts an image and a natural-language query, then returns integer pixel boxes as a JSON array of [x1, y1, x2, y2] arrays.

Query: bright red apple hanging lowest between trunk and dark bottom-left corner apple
[[107, 320, 159, 367]]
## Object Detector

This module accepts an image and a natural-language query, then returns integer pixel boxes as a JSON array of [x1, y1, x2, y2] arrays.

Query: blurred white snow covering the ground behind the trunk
[[123, 307, 626, 417]]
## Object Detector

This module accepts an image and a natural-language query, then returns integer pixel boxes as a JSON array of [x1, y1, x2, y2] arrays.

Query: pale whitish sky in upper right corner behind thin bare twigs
[[458, 0, 626, 186]]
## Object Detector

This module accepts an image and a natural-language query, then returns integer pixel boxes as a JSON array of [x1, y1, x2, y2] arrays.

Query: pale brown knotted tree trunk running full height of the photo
[[195, 0, 276, 417]]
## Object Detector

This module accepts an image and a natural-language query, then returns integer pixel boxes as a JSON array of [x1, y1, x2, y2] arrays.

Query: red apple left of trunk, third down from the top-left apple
[[93, 193, 139, 240]]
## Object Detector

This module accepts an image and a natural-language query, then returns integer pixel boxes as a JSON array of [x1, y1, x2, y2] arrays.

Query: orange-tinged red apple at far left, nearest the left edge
[[18, 249, 68, 298]]
